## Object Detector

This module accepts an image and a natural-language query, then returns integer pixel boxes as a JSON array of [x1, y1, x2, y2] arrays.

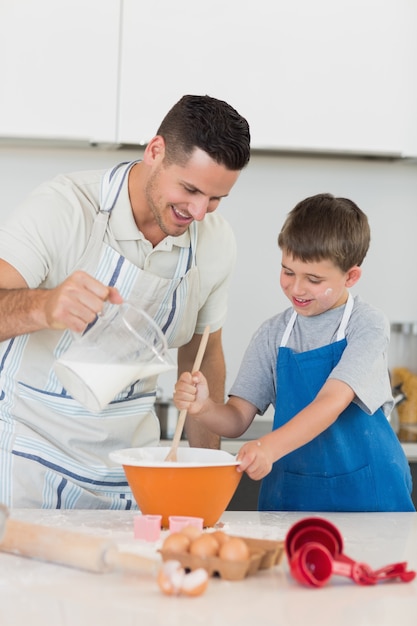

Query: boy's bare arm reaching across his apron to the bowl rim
[[238, 379, 355, 480]]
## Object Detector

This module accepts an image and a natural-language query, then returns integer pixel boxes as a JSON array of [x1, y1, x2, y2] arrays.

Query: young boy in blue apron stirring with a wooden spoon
[[174, 194, 415, 511]]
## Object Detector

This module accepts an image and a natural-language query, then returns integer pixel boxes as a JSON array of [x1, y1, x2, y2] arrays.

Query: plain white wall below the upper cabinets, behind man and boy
[[0, 145, 417, 396]]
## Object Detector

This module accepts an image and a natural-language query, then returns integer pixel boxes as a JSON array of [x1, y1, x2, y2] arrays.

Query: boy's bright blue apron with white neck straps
[[258, 298, 415, 511]]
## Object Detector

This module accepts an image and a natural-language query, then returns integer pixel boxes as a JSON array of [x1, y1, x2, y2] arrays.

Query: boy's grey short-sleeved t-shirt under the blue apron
[[229, 296, 393, 416]]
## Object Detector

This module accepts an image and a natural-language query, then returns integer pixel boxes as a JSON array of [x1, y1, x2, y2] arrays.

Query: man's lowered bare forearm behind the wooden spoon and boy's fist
[[178, 329, 226, 449]]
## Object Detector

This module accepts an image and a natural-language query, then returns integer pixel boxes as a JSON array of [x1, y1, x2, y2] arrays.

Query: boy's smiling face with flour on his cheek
[[280, 252, 361, 317]]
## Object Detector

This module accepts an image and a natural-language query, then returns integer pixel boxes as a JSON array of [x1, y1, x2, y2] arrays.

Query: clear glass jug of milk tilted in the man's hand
[[54, 303, 175, 412]]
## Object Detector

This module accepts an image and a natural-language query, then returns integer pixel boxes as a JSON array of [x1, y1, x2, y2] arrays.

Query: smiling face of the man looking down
[[145, 149, 240, 237]]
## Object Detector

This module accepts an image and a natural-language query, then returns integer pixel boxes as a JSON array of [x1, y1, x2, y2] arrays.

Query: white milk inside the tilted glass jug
[[54, 358, 174, 413]]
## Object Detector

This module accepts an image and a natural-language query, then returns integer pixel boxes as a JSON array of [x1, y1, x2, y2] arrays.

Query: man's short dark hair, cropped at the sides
[[157, 96, 250, 171]]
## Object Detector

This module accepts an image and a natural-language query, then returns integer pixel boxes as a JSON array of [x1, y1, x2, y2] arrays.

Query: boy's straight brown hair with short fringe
[[278, 193, 371, 272]]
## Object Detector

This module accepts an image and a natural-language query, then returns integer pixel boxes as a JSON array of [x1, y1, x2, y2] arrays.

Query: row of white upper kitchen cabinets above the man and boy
[[0, 0, 417, 157]]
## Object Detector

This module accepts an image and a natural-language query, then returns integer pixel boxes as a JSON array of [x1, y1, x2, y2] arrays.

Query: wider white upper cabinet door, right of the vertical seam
[[118, 0, 417, 155]]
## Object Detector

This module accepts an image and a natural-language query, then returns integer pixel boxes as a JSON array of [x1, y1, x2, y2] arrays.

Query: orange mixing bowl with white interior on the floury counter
[[110, 446, 242, 528]]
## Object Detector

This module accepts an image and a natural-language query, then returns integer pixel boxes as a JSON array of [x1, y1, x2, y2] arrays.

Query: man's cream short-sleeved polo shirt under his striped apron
[[0, 170, 236, 333]]
